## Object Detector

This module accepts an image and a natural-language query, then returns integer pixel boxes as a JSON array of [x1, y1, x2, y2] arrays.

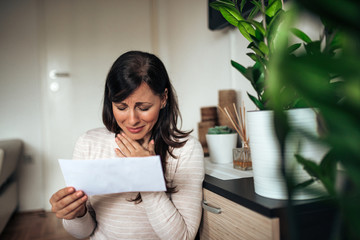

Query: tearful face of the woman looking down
[[112, 82, 167, 141]]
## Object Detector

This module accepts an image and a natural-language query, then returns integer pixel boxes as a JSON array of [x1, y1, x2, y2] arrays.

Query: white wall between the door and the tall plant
[[157, 0, 253, 136]]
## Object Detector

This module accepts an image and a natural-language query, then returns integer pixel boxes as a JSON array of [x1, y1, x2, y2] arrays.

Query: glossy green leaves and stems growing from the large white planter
[[210, 0, 307, 110]]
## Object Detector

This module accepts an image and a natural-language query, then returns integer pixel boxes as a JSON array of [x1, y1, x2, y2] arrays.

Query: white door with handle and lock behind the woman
[[43, 0, 152, 208]]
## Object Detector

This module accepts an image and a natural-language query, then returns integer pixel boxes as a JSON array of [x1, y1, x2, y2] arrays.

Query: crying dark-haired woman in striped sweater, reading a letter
[[50, 51, 204, 239]]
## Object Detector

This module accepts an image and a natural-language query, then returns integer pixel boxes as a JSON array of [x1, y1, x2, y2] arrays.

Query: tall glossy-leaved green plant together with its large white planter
[[210, 0, 333, 199]]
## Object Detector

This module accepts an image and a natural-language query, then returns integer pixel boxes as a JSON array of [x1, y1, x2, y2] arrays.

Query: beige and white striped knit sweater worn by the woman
[[63, 128, 204, 240]]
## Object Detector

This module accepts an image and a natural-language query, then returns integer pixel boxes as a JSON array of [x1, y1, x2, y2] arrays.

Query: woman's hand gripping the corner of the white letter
[[50, 187, 88, 220]]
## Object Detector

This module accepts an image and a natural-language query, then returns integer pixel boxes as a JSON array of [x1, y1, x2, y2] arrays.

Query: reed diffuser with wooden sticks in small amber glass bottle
[[219, 103, 252, 170]]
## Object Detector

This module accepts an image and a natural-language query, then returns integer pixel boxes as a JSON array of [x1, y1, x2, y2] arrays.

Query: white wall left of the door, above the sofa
[[0, 0, 44, 209]]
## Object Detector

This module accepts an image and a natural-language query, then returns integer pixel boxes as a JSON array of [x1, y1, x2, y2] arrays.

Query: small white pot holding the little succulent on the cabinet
[[206, 133, 237, 163]]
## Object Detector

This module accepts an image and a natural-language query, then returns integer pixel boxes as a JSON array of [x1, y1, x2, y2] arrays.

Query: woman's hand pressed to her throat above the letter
[[115, 133, 155, 157]]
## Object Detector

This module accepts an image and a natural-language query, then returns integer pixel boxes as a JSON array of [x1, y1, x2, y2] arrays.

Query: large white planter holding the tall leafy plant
[[247, 108, 328, 200]]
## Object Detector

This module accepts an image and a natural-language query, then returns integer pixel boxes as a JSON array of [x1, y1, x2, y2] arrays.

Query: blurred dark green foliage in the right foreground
[[269, 0, 360, 239]]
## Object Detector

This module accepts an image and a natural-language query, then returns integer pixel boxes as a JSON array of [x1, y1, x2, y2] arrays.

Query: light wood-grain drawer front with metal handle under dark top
[[200, 189, 280, 240]]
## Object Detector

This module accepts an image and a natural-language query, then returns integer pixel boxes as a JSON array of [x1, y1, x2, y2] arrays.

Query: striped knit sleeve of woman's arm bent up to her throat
[[141, 138, 204, 240]]
